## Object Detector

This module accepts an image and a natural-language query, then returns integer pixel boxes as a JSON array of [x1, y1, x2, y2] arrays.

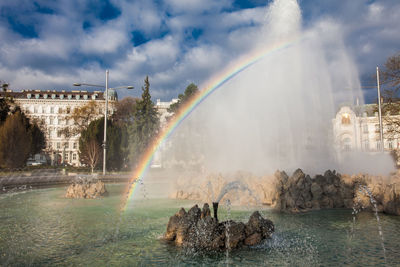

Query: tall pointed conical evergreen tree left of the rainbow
[[128, 76, 160, 164]]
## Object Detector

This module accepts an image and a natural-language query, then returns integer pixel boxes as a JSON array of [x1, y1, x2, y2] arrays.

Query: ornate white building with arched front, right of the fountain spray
[[332, 104, 400, 153]]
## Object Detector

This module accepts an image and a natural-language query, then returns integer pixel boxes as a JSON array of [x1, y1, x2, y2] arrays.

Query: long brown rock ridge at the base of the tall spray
[[172, 169, 400, 215]]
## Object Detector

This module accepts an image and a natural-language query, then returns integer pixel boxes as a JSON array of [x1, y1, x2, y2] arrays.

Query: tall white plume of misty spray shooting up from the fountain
[[163, 0, 394, 177]]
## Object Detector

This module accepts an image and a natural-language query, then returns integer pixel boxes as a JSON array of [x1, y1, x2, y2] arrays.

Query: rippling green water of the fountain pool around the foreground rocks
[[0, 185, 400, 266]]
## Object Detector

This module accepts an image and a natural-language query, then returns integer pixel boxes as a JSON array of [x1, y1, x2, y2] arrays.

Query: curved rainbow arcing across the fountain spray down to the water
[[121, 38, 299, 211]]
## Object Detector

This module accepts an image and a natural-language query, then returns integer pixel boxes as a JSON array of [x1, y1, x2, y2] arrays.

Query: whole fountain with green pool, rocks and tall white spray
[[0, 0, 400, 266]]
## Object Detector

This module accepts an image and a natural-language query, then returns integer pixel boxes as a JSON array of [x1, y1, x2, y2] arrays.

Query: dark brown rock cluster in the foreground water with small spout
[[164, 203, 274, 251]]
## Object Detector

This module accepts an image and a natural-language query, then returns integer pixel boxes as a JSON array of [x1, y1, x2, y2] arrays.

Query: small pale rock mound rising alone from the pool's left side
[[65, 180, 107, 198]]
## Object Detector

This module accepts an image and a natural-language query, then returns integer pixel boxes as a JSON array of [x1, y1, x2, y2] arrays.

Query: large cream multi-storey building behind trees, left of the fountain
[[0, 90, 118, 166]]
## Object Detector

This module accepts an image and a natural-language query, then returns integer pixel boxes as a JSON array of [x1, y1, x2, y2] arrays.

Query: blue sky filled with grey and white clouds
[[0, 0, 400, 102]]
